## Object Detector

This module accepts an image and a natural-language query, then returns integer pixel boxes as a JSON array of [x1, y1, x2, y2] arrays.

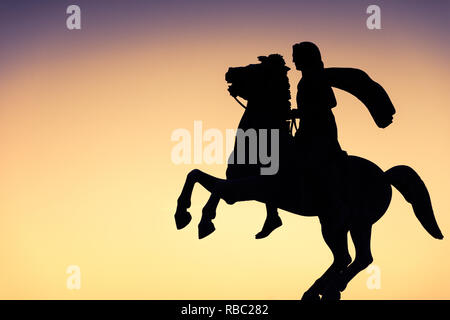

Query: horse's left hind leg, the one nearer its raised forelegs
[[302, 218, 352, 300]]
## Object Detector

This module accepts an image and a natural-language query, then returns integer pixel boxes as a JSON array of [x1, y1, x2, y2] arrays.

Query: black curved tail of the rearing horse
[[385, 166, 444, 239]]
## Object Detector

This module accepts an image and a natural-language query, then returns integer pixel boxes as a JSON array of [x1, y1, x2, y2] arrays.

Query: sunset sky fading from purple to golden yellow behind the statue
[[0, 0, 450, 299]]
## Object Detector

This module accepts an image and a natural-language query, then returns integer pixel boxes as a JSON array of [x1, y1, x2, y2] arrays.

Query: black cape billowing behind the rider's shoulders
[[325, 68, 395, 128]]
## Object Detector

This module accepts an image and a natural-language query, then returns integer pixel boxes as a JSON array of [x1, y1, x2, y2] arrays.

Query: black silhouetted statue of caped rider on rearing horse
[[175, 42, 443, 300]]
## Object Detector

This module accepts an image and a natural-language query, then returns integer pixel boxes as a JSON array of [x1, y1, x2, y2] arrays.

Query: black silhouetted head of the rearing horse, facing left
[[225, 54, 291, 112]]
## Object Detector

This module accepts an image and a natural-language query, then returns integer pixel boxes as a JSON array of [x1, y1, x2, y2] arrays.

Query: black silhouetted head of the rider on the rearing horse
[[292, 42, 323, 71]]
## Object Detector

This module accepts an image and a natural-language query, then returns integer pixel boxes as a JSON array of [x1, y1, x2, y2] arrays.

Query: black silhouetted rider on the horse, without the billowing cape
[[256, 42, 345, 239]]
